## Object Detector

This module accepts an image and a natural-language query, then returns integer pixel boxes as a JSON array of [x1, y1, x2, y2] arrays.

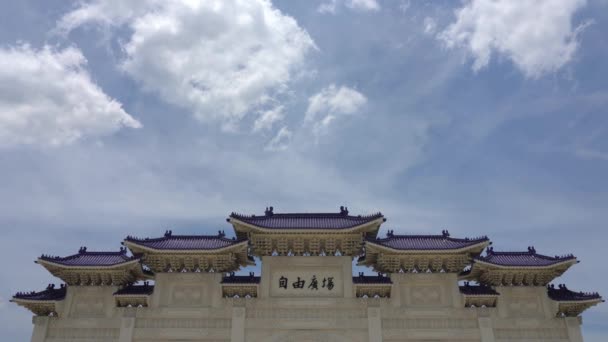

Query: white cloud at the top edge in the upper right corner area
[[439, 0, 586, 78]]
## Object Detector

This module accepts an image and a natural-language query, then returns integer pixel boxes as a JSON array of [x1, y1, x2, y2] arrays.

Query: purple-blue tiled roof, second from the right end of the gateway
[[475, 247, 576, 267]]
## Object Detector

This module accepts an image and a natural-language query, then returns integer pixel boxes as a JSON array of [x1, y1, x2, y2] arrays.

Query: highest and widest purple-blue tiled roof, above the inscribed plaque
[[228, 207, 384, 229]]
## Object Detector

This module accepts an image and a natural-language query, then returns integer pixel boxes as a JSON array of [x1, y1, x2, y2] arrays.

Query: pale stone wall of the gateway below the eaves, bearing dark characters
[[32, 257, 582, 342]]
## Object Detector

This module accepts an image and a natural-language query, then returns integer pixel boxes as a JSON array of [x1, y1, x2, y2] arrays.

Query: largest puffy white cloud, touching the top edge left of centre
[[58, 0, 315, 129]]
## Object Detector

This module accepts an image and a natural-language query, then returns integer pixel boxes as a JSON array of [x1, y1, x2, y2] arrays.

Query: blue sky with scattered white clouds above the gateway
[[0, 0, 608, 341]]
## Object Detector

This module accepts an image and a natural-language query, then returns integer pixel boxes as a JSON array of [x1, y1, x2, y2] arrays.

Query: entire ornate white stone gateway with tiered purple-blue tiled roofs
[[12, 207, 603, 342]]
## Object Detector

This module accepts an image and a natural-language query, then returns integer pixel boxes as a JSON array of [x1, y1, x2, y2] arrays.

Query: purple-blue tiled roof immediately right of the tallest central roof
[[367, 230, 489, 250]]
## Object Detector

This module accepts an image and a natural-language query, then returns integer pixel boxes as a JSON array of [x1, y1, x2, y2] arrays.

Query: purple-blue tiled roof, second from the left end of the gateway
[[39, 247, 139, 266]]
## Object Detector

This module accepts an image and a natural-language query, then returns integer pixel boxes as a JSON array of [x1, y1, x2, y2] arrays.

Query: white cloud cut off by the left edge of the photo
[[0, 45, 141, 147]]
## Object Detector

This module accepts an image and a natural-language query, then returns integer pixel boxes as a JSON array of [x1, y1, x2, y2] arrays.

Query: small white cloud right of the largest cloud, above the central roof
[[304, 84, 367, 135]]
